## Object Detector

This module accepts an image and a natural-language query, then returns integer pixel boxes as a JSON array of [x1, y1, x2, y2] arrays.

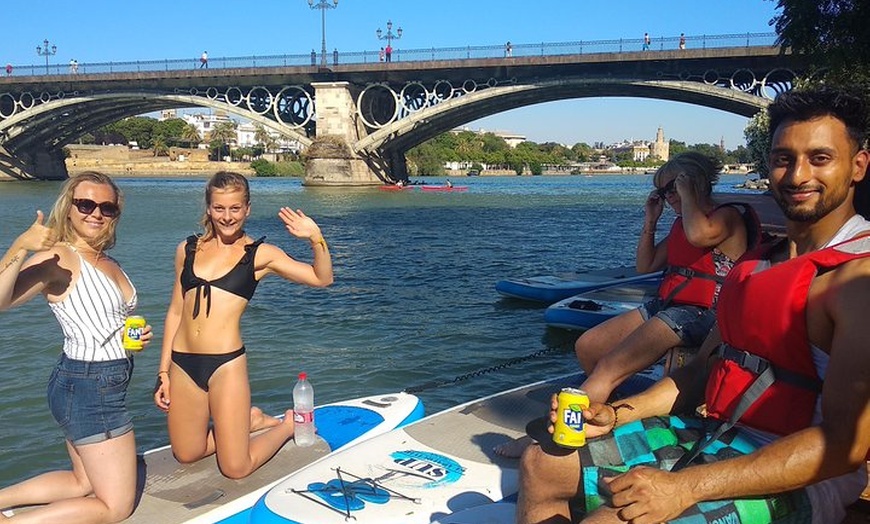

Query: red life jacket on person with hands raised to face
[[658, 203, 761, 308]]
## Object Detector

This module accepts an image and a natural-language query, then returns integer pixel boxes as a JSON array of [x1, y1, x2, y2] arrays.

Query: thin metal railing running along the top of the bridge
[[3, 33, 776, 76]]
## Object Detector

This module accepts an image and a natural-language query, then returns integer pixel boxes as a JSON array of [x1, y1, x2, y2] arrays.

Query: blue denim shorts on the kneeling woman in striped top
[[48, 354, 133, 446]]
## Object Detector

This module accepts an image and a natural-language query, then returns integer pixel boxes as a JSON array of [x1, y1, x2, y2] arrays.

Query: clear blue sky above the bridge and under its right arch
[[0, 0, 777, 149]]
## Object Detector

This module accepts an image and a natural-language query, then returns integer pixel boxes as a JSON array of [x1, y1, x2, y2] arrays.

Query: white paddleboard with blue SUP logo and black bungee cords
[[244, 373, 653, 524]]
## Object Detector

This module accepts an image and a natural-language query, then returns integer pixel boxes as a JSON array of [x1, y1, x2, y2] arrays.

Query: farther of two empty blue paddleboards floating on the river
[[495, 266, 662, 304]]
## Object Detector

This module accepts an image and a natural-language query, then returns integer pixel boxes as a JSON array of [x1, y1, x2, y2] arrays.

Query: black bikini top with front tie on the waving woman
[[180, 235, 266, 318]]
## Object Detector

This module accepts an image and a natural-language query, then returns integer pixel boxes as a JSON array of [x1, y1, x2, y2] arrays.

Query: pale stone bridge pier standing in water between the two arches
[[303, 82, 392, 186]]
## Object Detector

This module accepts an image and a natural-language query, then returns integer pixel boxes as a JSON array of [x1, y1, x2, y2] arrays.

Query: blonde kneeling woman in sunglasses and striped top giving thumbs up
[[0, 172, 152, 524]]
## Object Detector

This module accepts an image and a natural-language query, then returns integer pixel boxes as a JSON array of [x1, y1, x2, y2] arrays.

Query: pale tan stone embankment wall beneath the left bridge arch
[[66, 144, 254, 177]]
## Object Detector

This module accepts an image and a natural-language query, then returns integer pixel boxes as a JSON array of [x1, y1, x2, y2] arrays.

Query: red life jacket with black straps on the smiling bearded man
[[705, 236, 870, 435]]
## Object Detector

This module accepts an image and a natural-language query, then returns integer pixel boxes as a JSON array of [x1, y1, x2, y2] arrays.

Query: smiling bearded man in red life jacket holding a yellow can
[[517, 89, 870, 524]]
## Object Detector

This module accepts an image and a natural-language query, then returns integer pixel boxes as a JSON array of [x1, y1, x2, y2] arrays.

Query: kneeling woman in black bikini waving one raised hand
[[154, 172, 332, 478]]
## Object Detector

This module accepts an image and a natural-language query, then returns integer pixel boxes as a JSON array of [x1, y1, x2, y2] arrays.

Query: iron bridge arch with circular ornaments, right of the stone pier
[[354, 68, 797, 155]]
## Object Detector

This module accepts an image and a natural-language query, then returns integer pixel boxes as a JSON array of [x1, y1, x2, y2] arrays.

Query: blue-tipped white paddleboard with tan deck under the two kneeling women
[[124, 393, 423, 524]]
